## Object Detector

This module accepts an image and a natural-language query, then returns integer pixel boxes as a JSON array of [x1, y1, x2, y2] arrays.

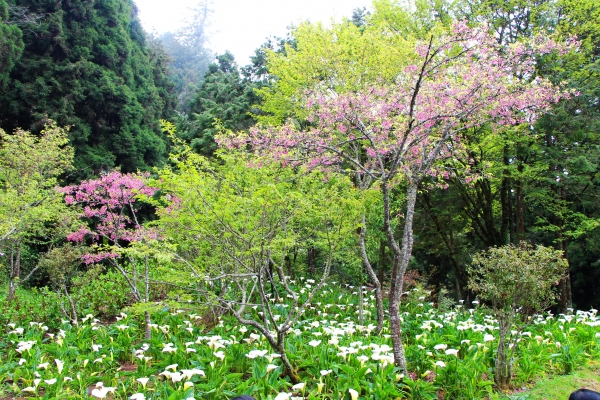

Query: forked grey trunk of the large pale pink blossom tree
[[381, 180, 417, 374]]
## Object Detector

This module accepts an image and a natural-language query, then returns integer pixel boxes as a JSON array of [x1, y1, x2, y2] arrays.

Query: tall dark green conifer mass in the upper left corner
[[0, 0, 174, 176]]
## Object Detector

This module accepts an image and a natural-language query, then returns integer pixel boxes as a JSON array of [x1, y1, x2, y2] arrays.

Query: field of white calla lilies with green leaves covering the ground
[[0, 283, 600, 400]]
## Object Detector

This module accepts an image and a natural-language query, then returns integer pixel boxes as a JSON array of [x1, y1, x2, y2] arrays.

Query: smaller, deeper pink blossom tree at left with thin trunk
[[61, 171, 157, 338]]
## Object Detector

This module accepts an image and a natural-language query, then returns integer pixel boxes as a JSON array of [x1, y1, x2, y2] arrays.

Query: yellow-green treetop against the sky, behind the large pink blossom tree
[[257, 21, 412, 124]]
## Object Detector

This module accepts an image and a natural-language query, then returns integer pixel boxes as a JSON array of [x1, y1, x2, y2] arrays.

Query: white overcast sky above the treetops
[[134, 0, 371, 66]]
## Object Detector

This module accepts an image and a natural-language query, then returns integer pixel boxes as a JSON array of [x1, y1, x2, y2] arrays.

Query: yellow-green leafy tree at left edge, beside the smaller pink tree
[[0, 122, 73, 297]]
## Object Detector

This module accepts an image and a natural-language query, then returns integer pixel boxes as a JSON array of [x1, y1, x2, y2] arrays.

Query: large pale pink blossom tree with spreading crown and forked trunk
[[218, 23, 568, 372]]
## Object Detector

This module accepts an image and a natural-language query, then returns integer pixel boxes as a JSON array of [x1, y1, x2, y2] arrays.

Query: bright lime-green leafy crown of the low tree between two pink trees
[[156, 148, 362, 282]]
